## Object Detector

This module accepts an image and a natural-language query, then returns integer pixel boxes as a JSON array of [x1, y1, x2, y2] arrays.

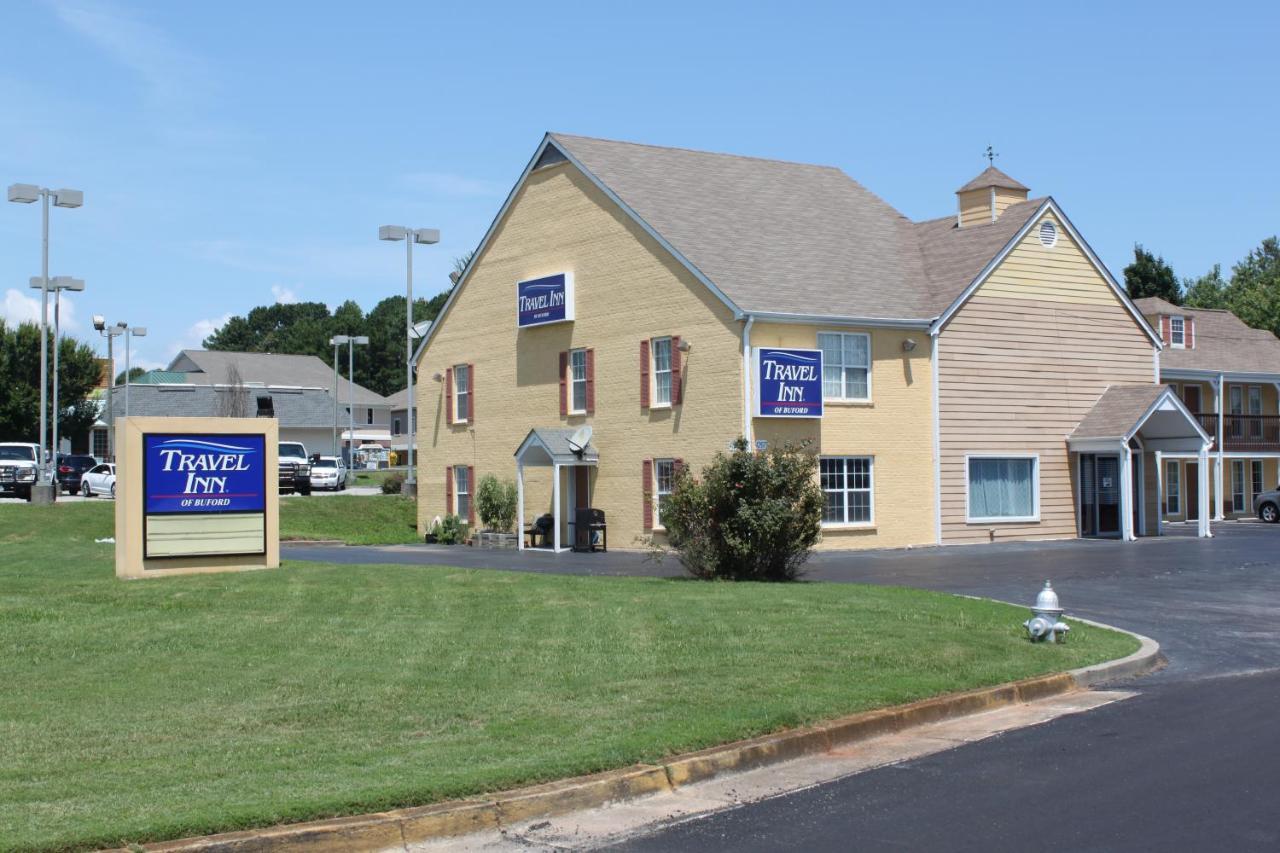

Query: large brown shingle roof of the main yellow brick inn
[[549, 133, 1042, 320]]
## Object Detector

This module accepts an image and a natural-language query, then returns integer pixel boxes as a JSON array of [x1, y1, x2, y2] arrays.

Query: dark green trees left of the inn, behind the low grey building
[[204, 254, 471, 396]]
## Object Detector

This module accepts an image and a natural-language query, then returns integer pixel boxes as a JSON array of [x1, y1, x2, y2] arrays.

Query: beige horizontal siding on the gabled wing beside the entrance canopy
[[938, 212, 1153, 543]]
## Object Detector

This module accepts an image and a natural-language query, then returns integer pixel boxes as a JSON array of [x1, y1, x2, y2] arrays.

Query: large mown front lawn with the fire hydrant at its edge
[[0, 498, 1137, 848]]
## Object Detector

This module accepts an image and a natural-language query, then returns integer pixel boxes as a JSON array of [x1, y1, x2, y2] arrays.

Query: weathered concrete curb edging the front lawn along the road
[[122, 617, 1164, 853]]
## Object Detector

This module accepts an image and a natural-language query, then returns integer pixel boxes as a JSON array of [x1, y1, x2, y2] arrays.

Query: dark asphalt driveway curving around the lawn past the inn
[[285, 524, 1280, 853]]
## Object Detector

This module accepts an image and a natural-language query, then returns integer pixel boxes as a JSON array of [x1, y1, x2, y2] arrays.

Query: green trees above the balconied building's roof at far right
[[1124, 237, 1280, 337]]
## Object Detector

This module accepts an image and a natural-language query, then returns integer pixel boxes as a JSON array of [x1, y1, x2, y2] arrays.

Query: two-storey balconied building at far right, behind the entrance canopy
[[1137, 297, 1280, 520]]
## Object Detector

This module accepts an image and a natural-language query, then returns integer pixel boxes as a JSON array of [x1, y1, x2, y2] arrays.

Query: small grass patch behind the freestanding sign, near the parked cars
[[280, 494, 420, 544]]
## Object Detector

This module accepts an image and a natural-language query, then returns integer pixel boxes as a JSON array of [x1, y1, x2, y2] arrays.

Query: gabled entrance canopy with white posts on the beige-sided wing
[[1066, 384, 1213, 539]]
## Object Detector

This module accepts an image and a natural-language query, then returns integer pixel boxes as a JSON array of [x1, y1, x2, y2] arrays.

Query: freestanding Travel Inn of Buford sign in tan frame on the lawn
[[115, 418, 280, 578]]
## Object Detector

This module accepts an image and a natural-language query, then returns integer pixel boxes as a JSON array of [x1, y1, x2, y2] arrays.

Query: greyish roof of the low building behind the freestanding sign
[[169, 350, 387, 406]]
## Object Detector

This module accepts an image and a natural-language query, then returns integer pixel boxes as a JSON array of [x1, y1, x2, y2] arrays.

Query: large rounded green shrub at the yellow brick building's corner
[[662, 438, 823, 580]]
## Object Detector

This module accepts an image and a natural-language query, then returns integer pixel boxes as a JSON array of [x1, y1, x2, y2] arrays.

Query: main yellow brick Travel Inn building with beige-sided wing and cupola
[[416, 134, 1210, 548]]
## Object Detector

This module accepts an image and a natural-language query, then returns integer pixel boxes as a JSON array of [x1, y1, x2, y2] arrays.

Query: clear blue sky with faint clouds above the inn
[[0, 0, 1280, 366]]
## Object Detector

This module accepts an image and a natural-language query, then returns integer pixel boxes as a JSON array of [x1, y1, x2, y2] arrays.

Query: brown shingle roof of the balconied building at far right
[[1134, 296, 1280, 375]]
